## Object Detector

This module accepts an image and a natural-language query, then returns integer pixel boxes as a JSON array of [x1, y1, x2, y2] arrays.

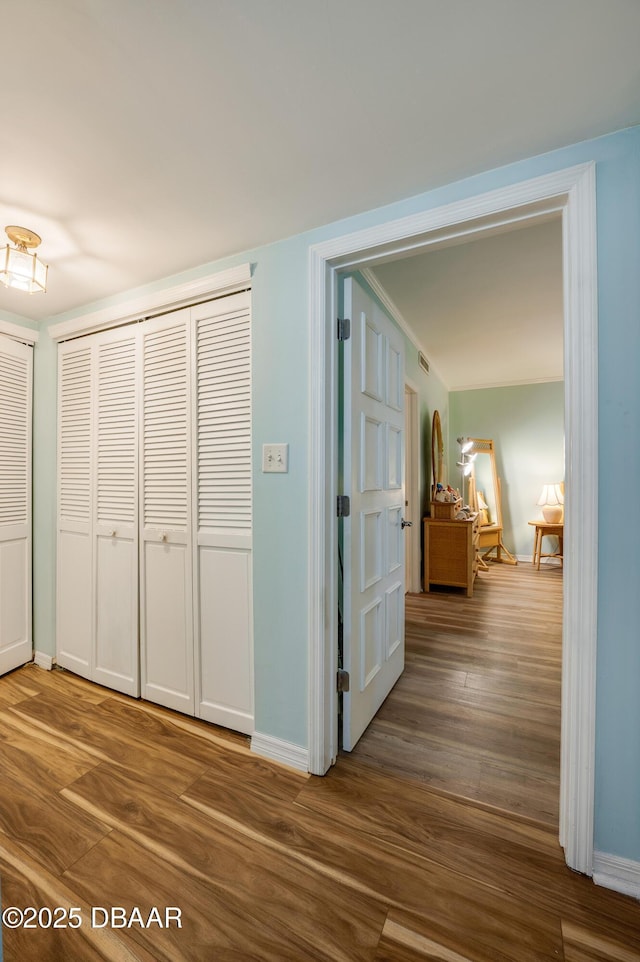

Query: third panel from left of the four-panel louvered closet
[[140, 309, 195, 715]]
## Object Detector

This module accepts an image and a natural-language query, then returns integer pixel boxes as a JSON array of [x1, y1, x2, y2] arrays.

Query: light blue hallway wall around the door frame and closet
[[35, 122, 640, 860]]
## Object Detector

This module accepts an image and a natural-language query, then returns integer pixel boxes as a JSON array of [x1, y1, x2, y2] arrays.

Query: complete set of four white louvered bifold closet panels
[[57, 292, 253, 733]]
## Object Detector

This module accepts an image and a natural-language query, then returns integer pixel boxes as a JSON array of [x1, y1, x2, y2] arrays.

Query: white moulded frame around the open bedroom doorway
[[308, 163, 598, 875]]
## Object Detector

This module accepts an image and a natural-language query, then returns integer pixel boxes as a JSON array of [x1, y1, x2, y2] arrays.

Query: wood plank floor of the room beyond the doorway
[[353, 563, 562, 828]]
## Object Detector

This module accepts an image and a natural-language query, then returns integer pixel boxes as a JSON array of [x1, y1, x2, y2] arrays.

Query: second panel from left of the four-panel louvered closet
[[92, 327, 140, 696]]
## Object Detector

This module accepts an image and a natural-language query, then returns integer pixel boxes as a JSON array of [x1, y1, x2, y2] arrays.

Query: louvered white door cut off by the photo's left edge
[[0, 336, 33, 674]]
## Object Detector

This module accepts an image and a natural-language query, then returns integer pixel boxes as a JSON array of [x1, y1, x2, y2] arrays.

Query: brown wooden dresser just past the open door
[[424, 514, 480, 598]]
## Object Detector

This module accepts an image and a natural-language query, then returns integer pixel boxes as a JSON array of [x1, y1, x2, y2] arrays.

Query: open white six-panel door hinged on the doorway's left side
[[342, 278, 405, 751]]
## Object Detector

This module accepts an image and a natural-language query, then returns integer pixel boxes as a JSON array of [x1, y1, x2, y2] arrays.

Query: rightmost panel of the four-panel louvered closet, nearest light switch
[[192, 293, 254, 733]]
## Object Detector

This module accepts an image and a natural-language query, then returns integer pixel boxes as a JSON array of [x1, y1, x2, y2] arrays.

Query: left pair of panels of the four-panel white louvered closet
[[57, 327, 140, 695]]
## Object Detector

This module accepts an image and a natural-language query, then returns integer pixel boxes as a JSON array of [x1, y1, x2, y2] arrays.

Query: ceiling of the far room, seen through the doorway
[[373, 214, 563, 391]]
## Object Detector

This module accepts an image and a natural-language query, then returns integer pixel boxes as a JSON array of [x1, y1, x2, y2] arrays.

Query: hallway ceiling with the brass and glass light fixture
[[0, 0, 640, 319]]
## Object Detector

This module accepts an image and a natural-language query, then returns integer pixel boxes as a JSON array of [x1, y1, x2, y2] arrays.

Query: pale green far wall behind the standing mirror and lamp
[[449, 381, 564, 558]]
